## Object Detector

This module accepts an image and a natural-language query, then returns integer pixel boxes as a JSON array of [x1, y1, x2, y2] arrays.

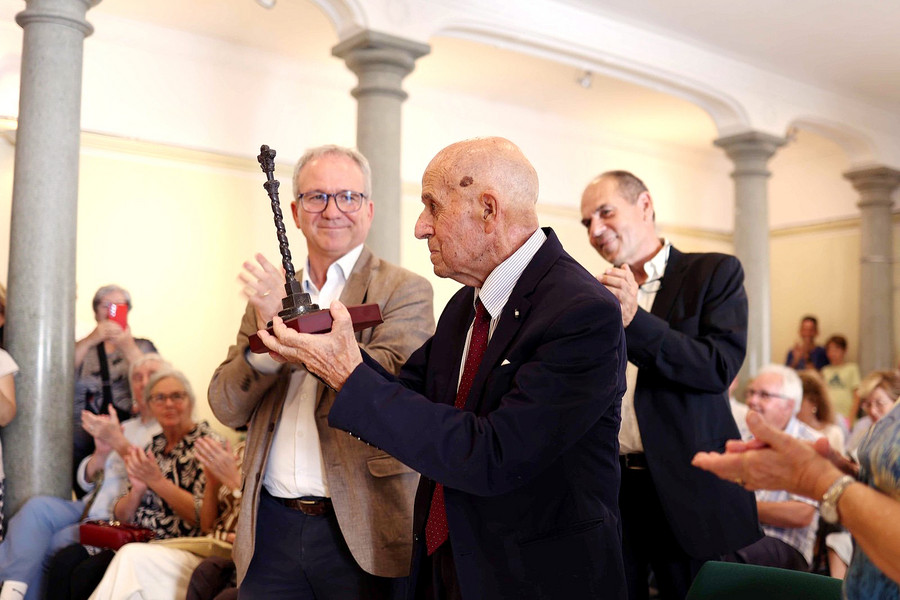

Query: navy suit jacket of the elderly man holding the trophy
[[329, 229, 626, 600]]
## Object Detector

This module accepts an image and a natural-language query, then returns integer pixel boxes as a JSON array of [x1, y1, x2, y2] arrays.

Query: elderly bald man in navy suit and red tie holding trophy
[[261, 138, 625, 600]]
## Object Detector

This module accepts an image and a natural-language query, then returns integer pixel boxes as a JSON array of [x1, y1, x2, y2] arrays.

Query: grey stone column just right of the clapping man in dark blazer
[[714, 131, 785, 379]]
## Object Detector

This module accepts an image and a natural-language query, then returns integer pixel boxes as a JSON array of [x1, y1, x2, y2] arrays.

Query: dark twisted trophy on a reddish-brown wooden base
[[250, 145, 383, 354]]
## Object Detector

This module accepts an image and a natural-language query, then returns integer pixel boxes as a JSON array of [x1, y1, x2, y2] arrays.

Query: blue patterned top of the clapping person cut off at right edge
[[844, 403, 900, 600]]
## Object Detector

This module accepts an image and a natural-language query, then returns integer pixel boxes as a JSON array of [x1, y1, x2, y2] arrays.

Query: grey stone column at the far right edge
[[844, 162, 900, 374]]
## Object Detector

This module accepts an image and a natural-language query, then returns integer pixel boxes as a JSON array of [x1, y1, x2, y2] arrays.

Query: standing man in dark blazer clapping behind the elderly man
[[581, 171, 761, 600]]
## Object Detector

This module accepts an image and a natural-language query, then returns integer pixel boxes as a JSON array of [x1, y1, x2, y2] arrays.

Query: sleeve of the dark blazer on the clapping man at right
[[626, 256, 747, 394]]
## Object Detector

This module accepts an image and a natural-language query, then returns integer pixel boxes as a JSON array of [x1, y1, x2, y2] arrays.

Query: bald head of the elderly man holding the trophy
[[416, 137, 538, 287]]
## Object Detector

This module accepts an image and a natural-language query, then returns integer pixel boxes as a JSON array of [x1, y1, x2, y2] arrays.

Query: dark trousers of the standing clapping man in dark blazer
[[619, 466, 718, 600]]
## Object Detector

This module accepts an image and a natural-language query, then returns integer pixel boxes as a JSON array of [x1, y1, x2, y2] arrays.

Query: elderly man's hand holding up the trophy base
[[259, 300, 362, 390]]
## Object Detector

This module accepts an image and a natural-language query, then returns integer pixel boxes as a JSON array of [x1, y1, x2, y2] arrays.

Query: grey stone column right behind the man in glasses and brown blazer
[[331, 30, 431, 264]]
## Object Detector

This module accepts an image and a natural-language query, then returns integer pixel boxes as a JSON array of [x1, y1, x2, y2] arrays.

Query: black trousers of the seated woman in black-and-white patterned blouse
[[45, 544, 116, 600]]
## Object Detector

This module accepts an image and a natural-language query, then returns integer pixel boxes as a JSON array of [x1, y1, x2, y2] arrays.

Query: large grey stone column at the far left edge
[[3, 0, 99, 514]]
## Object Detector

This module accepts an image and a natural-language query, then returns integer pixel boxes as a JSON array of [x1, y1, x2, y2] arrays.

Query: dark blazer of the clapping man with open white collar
[[625, 247, 761, 558]]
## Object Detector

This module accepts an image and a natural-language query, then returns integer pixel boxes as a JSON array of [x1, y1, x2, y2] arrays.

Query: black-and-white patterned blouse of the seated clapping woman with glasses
[[133, 421, 222, 539]]
